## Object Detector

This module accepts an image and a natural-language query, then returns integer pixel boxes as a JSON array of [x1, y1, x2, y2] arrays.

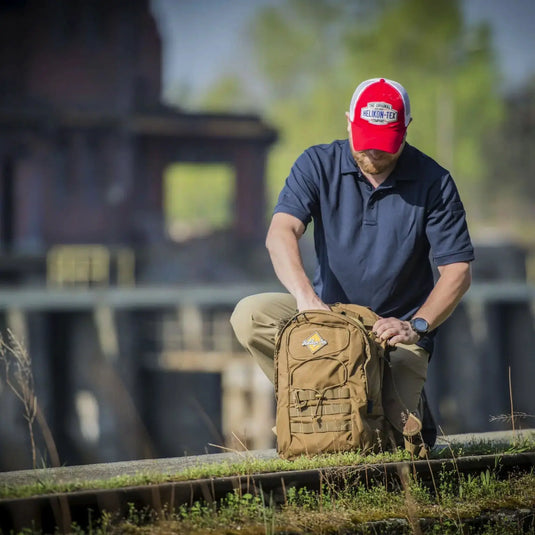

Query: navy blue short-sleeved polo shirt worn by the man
[[274, 140, 474, 352]]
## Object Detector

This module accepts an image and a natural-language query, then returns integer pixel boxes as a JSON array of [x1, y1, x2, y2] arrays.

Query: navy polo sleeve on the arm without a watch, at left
[[274, 151, 319, 227]]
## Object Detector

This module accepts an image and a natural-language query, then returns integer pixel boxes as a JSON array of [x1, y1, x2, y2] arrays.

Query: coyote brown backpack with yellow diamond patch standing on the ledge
[[275, 304, 390, 459]]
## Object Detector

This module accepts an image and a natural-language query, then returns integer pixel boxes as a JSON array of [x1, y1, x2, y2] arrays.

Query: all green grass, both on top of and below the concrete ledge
[[2, 440, 535, 535]]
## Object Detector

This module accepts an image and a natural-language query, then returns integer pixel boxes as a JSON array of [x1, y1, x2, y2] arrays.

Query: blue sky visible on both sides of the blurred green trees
[[152, 0, 535, 108]]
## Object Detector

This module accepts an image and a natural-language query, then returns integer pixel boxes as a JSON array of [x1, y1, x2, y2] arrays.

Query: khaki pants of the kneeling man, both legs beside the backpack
[[230, 293, 429, 432]]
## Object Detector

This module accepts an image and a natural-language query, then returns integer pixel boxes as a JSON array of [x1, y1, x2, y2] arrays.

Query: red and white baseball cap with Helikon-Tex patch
[[349, 78, 411, 154]]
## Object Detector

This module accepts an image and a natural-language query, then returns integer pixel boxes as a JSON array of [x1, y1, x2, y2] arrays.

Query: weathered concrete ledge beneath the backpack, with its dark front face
[[0, 430, 535, 533]]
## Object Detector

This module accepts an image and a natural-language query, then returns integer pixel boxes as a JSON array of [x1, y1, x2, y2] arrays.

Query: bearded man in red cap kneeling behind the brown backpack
[[231, 78, 474, 450]]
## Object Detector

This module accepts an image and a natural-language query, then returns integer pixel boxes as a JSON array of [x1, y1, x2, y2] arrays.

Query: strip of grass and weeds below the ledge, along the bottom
[[70, 471, 535, 535]]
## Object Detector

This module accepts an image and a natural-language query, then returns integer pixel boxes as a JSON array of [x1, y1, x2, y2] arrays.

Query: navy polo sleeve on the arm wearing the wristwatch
[[426, 174, 474, 266]]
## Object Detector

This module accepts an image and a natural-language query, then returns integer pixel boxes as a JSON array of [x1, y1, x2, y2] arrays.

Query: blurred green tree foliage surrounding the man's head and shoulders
[[248, 0, 502, 215]]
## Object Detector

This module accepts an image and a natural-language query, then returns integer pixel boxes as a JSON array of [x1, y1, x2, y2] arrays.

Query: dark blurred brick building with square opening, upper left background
[[0, 0, 275, 268]]
